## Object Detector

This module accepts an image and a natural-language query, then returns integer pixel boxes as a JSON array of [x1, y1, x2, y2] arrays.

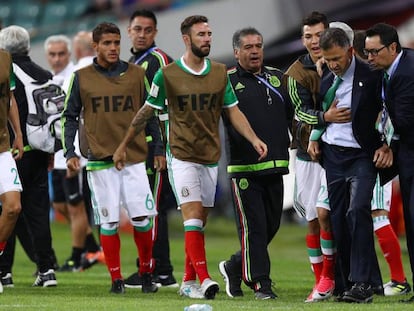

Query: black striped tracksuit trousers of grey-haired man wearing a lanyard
[[229, 174, 283, 288]]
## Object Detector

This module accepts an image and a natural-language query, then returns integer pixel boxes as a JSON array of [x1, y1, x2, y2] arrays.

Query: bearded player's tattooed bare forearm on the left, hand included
[[112, 105, 154, 170]]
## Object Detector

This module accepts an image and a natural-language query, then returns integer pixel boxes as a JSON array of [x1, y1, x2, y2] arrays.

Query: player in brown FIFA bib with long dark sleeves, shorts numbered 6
[[62, 23, 157, 294]]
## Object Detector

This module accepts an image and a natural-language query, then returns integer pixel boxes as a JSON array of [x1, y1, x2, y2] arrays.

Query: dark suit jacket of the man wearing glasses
[[385, 49, 414, 146]]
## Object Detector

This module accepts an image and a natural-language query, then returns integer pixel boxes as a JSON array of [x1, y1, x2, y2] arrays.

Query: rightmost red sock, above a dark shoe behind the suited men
[[375, 224, 406, 282]]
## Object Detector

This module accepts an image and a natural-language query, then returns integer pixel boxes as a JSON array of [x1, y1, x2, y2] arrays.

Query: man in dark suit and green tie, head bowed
[[308, 28, 392, 303]]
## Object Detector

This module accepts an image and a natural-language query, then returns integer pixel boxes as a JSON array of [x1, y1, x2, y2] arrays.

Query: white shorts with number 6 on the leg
[[87, 163, 157, 224]]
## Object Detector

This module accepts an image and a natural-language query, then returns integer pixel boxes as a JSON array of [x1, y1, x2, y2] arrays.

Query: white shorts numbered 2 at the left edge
[[0, 151, 23, 194]]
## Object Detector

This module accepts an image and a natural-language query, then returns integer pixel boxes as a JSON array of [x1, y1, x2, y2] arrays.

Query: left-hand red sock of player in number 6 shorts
[[101, 233, 122, 282]]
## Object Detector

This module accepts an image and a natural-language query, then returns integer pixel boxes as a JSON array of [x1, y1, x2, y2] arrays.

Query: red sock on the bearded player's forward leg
[[184, 231, 210, 284]]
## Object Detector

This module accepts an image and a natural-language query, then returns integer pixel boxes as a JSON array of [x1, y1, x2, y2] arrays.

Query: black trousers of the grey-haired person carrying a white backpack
[[0, 150, 54, 272]]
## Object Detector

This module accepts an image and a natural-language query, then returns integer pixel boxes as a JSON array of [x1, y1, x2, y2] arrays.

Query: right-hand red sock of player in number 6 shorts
[[134, 230, 154, 274]]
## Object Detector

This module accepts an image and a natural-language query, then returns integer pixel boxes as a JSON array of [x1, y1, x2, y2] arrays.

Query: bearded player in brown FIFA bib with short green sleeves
[[113, 15, 267, 299]]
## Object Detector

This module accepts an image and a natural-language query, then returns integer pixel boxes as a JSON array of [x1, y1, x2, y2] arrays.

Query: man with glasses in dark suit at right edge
[[364, 23, 414, 303]]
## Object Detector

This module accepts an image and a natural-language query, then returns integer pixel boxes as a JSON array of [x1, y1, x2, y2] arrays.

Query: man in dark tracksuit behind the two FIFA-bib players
[[125, 10, 178, 288]]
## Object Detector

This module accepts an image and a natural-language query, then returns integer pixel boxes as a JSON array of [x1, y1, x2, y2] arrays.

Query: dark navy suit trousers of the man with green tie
[[322, 143, 382, 290]]
